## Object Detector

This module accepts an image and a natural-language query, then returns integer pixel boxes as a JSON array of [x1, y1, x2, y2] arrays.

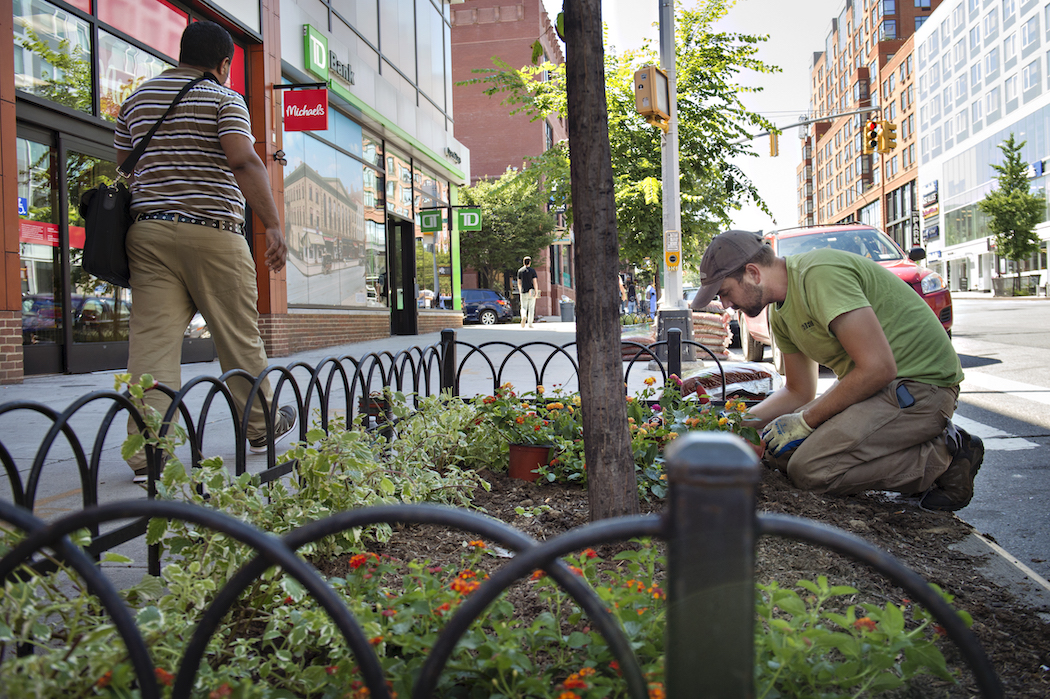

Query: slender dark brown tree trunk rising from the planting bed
[[565, 0, 638, 521]]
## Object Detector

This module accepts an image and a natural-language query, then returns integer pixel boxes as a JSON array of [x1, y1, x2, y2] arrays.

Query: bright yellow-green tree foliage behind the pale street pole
[[465, 0, 779, 272]]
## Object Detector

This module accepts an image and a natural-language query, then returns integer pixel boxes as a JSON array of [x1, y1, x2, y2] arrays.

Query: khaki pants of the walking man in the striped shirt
[[127, 220, 273, 457]]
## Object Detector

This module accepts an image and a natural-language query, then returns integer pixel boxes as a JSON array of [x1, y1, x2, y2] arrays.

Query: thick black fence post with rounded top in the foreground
[[665, 432, 761, 699]]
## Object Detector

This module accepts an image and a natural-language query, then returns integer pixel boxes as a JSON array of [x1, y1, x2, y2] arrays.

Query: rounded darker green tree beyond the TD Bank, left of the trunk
[[460, 169, 554, 284]]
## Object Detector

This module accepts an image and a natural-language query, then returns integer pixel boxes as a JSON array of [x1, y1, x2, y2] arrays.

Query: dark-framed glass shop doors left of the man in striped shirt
[[17, 119, 215, 376]]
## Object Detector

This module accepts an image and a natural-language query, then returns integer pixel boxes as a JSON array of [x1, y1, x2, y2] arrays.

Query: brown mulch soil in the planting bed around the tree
[[354, 470, 1050, 699]]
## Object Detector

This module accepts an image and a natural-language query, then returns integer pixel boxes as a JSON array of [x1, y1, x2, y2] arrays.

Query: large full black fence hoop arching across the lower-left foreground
[[0, 500, 390, 699]]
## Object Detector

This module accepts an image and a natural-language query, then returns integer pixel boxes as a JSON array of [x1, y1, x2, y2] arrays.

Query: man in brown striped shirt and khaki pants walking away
[[113, 21, 296, 483]]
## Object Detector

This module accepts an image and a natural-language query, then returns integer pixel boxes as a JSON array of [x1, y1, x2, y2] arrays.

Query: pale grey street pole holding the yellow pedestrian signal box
[[659, 0, 692, 310]]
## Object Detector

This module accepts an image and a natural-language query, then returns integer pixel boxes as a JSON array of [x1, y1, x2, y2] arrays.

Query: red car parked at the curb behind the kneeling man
[[737, 224, 953, 368]]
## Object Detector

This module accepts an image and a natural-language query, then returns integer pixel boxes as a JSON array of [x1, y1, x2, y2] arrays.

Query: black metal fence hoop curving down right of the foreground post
[[757, 514, 1004, 698]]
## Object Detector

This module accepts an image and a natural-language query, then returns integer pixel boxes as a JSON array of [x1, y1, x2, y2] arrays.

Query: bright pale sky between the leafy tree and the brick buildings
[[543, 0, 844, 230]]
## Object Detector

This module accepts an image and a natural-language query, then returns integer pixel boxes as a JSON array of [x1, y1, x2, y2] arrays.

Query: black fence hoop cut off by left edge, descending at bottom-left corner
[[0, 501, 161, 699]]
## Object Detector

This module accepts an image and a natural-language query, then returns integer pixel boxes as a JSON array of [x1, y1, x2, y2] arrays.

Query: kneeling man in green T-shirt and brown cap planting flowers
[[692, 231, 984, 510]]
